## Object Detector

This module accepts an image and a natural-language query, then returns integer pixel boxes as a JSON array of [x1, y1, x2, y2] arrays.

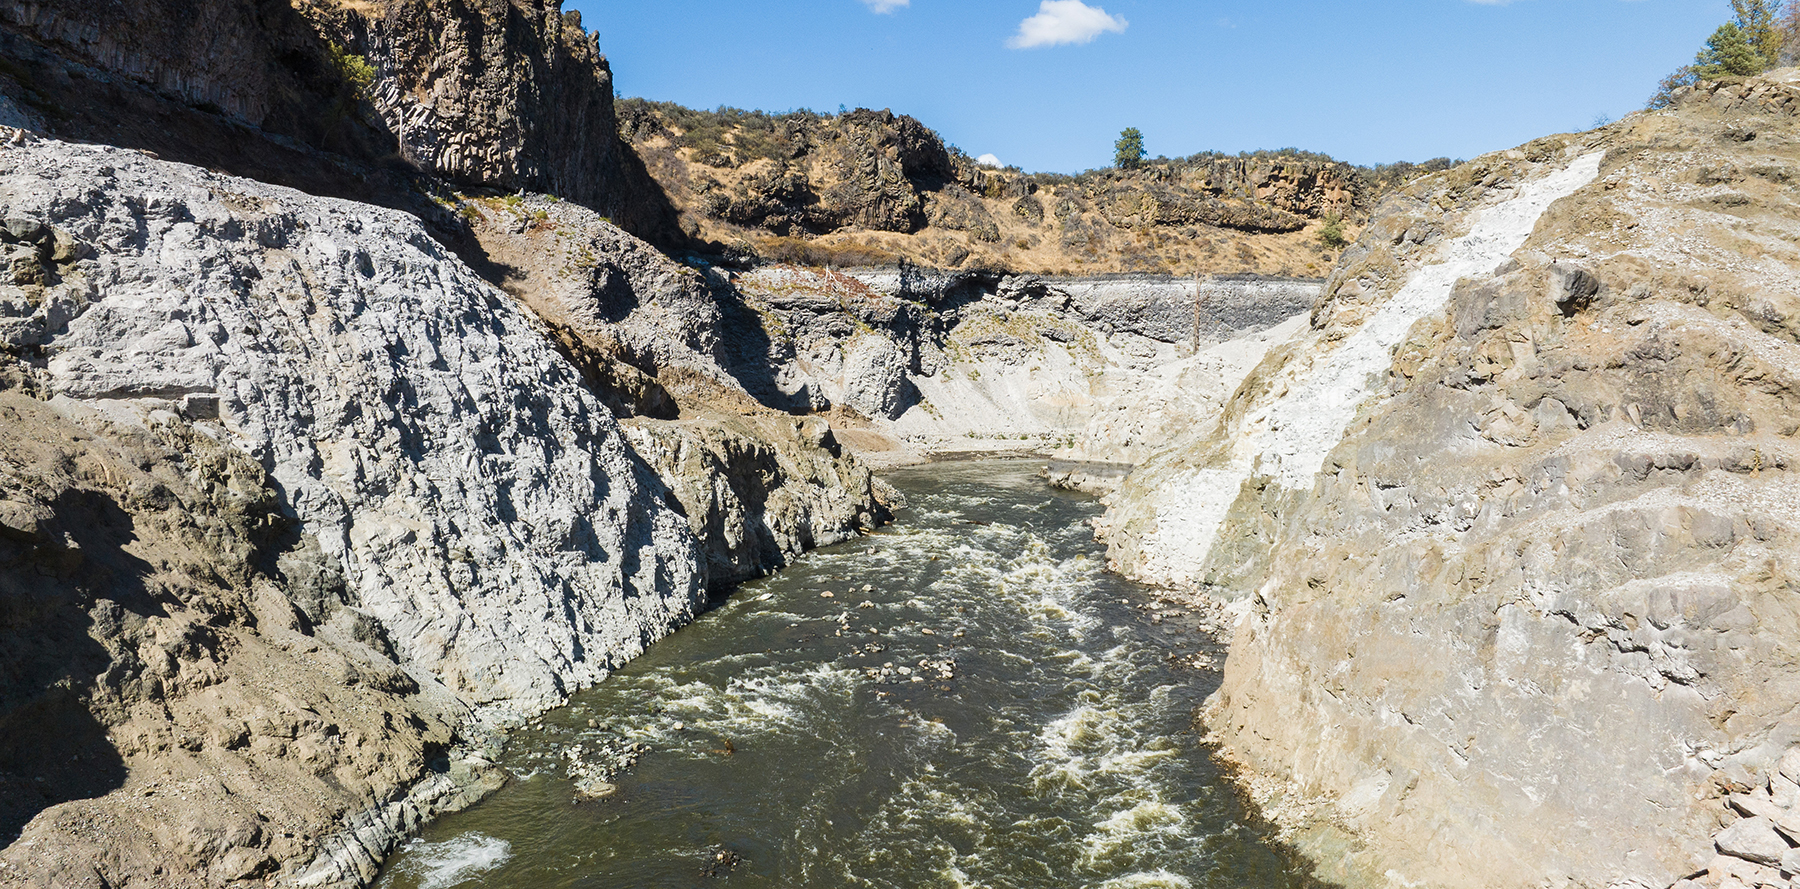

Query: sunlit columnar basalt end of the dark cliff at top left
[[301, 0, 679, 239]]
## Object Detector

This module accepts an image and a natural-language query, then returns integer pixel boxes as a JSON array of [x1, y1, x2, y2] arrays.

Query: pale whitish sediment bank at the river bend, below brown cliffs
[[738, 266, 1318, 462]]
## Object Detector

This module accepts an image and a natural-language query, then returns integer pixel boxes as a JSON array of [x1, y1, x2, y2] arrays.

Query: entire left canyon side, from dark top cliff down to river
[[0, 0, 900, 885]]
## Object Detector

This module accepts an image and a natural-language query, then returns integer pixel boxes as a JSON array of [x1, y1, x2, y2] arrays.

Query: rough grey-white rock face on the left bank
[[0, 134, 700, 709]]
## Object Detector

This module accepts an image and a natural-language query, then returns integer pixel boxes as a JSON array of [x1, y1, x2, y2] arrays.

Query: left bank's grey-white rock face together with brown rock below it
[[0, 133, 706, 885]]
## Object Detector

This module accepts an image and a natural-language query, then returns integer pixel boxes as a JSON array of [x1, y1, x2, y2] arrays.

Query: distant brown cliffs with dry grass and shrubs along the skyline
[[621, 99, 1418, 277]]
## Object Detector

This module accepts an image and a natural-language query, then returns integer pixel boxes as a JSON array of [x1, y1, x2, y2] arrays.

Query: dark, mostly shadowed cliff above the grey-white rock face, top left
[[0, 0, 680, 239]]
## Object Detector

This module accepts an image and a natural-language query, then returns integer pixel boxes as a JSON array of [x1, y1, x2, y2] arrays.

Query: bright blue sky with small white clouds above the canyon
[[563, 0, 1730, 173]]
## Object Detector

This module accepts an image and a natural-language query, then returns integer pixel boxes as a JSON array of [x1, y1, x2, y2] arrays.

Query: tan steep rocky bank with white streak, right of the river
[[1109, 70, 1800, 887]]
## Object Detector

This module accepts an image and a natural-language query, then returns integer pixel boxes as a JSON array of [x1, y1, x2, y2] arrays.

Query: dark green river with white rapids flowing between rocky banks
[[380, 461, 1310, 889]]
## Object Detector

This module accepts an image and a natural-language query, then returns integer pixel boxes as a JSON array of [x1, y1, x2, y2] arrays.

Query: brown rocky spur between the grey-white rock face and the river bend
[[450, 189, 902, 590]]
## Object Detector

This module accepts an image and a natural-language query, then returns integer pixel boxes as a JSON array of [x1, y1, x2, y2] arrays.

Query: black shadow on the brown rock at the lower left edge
[[0, 491, 164, 846]]
